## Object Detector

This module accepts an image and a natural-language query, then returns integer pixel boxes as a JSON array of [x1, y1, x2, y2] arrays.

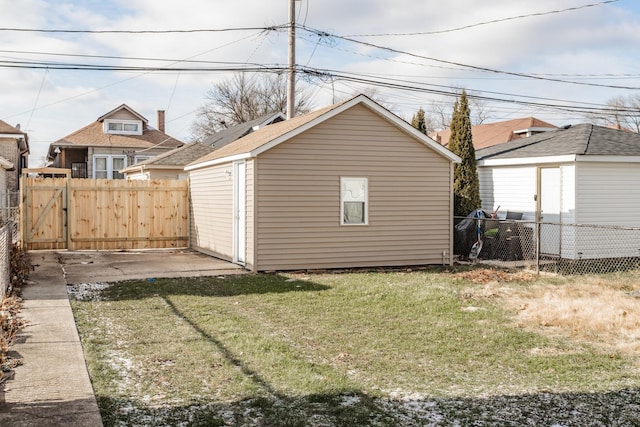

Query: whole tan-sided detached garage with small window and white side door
[[185, 95, 460, 271]]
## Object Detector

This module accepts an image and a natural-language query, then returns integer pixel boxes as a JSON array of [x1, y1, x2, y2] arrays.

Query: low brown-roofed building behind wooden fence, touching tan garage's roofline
[[120, 142, 214, 179]]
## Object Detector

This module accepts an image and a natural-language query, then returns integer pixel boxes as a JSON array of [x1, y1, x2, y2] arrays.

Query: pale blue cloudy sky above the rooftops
[[0, 0, 640, 167]]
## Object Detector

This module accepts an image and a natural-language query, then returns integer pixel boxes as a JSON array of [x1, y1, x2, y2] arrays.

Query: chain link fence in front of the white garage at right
[[454, 217, 640, 274]]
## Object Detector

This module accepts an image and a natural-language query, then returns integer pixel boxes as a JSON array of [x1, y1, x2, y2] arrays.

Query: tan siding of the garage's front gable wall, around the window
[[256, 106, 452, 270]]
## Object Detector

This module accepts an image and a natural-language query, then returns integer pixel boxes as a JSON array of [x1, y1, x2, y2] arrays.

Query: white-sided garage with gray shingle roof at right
[[476, 124, 640, 259]]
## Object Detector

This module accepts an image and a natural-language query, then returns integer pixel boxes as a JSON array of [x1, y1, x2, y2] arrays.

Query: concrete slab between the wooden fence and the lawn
[[57, 249, 247, 285]]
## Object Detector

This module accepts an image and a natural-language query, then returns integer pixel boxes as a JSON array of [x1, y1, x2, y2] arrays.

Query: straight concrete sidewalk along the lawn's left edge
[[0, 252, 102, 427]]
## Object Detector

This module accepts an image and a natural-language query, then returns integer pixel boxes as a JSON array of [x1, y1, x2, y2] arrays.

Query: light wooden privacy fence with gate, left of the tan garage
[[21, 176, 189, 250]]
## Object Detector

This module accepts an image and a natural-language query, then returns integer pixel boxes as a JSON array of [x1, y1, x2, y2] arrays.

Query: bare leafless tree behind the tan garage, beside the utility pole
[[191, 73, 311, 141]]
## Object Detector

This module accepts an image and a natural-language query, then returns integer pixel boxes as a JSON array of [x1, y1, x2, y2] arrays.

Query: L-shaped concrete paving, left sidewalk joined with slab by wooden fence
[[0, 250, 246, 427]]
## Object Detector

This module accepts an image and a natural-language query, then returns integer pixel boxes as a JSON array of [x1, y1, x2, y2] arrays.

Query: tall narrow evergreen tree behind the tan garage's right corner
[[449, 90, 480, 216]]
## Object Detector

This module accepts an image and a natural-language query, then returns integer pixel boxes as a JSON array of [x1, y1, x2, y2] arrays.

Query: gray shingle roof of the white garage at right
[[476, 124, 640, 160]]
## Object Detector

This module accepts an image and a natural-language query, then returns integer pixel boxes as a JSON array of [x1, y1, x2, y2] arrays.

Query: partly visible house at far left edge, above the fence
[[0, 120, 29, 202]]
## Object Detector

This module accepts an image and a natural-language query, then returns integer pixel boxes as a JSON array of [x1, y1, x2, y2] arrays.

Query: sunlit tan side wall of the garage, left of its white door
[[190, 164, 233, 260]]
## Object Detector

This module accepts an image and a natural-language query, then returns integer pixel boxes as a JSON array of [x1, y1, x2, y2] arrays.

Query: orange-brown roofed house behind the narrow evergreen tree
[[429, 117, 557, 150]]
